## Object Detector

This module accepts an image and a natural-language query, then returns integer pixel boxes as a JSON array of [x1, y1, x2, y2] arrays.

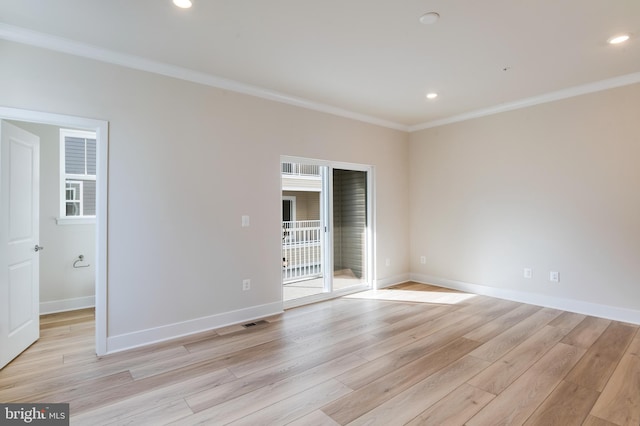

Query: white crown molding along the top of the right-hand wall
[[409, 72, 640, 132]]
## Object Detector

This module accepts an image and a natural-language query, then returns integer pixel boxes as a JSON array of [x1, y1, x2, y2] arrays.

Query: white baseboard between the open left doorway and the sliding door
[[107, 302, 283, 354]]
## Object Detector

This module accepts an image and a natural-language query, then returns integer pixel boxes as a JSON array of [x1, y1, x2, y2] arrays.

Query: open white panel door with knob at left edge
[[0, 121, 41, 368]]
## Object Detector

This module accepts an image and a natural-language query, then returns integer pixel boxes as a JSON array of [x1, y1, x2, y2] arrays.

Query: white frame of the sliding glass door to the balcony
[[278, 155, 377, 308]]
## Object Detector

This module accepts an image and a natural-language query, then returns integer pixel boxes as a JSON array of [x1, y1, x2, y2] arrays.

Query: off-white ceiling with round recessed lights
[[0, 0, 640, 130]]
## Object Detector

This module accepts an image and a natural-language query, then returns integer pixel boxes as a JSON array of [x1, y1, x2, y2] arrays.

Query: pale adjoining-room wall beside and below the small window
[[8, 121, 96, 314]]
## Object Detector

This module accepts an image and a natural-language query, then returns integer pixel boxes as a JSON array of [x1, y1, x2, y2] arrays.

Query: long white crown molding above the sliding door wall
[[0, 22, 409, 132]]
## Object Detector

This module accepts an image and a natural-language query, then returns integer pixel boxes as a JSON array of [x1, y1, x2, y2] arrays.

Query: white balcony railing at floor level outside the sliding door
[[282, 220, 322, 284]]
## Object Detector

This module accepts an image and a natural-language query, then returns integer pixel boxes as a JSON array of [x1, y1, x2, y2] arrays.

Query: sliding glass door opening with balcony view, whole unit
[[281, 157, 373, 307]]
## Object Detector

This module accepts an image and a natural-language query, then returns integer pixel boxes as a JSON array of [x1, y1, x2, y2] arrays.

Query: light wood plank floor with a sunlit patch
[[0, 283, 640, 426]]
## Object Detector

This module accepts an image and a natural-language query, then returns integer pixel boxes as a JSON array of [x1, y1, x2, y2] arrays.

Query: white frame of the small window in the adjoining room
[[56, 129, 97, 225]]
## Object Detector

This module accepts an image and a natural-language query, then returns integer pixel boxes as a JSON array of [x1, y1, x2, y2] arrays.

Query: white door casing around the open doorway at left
[[0, 106, 109, 355]]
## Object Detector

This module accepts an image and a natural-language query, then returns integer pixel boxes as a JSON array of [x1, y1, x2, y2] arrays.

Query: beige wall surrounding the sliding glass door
[[0, 42, 409, 349]]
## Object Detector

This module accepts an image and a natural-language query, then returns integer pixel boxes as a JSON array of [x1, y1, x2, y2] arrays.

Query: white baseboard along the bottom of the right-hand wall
[[411, 274, 640, 324]]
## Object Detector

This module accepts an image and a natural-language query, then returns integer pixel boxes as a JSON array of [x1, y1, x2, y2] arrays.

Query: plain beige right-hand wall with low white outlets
[[410, 84, 640, 322]]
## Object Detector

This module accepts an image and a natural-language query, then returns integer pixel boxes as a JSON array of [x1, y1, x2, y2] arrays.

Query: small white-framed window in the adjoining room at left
[[58, 129, 96, 224]]
